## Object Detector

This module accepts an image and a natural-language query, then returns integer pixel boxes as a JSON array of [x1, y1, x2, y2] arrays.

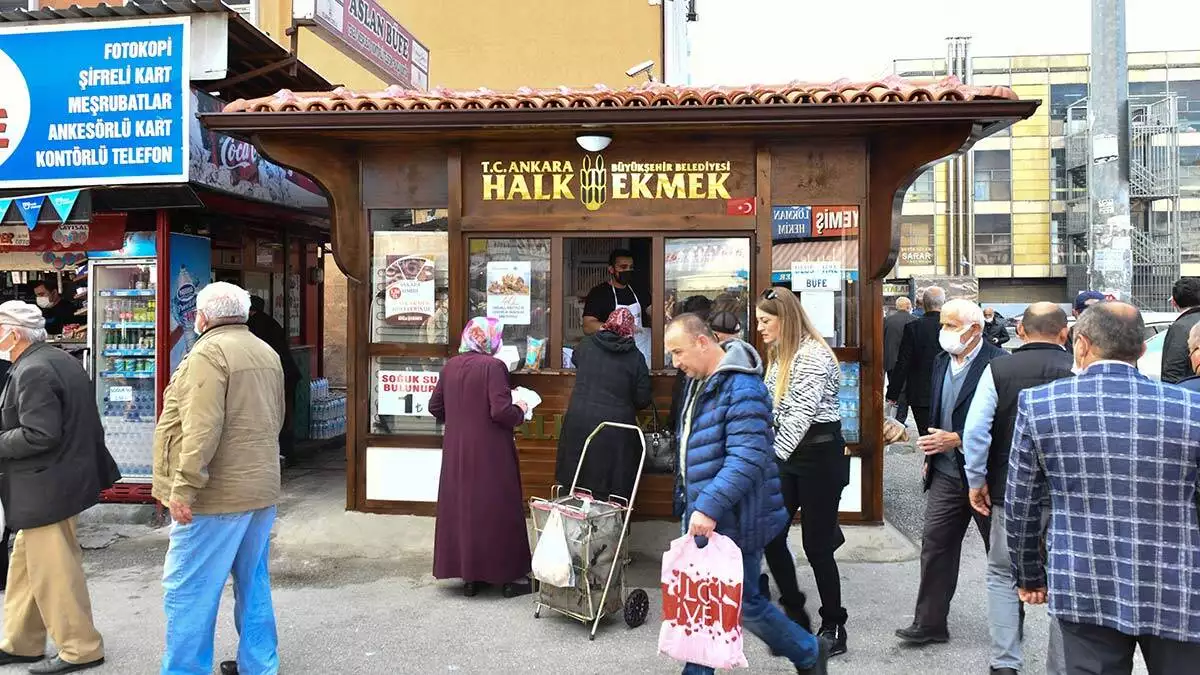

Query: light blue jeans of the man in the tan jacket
[[162, 507, 280, 675]]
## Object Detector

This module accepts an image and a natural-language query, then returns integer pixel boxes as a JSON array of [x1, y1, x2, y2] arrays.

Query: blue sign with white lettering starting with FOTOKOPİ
[[0, 17, 191, 189]]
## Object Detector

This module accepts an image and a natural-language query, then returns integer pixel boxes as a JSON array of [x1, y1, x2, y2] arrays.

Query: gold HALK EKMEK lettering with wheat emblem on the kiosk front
[[480, 155, 732, 211]]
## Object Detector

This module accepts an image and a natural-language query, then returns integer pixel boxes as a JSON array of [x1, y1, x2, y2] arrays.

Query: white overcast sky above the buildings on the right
[[691, 0, 1200, 84]]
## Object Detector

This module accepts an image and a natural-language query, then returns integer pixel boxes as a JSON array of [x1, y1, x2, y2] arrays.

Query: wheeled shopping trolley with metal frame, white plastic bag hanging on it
[[529, 422, 650, 640]]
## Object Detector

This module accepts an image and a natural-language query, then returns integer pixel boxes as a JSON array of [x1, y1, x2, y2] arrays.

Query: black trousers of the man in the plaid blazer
[[1058, 621, 1200, 675]]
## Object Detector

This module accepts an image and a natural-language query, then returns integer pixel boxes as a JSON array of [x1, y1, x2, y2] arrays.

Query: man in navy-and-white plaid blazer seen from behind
[[1004, 303, 1200, 675]]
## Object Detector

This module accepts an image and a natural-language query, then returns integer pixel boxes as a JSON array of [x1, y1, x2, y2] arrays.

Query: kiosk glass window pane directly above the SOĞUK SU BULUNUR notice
[[370, 209, 450, 345]]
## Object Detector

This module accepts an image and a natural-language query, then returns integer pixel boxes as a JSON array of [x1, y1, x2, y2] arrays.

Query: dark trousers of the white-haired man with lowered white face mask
[[913, 466, 988, 632]]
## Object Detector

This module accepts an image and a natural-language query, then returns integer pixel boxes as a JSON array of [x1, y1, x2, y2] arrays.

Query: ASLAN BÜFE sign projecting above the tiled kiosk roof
[[307, 0, 430, 90]]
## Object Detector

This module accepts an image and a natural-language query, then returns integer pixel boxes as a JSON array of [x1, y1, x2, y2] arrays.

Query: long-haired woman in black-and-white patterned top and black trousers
[[757, 288, 850, 655]]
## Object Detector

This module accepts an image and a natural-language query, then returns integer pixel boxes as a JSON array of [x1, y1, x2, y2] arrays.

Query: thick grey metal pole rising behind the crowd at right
[[1087, 0, 1133, 301]]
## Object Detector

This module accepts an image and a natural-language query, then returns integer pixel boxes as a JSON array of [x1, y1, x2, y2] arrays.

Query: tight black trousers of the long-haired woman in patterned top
[[764, 442, 850, 626]]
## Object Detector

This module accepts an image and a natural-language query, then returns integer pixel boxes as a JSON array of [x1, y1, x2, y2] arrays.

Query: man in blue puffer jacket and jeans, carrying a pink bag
[[666, 313, 829, 675]]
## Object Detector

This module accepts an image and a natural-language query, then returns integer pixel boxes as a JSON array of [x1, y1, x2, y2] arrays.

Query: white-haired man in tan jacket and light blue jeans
[[154, 282, 284, 675]]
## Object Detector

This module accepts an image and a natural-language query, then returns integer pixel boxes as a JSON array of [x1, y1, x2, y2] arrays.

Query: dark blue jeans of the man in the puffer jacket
[[683, 542, 820, 675]]
